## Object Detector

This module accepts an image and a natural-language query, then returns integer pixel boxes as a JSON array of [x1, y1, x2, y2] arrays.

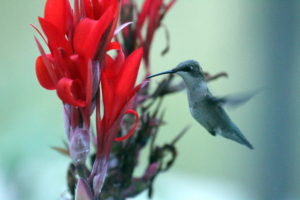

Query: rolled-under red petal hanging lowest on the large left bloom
[[56, 78, 85, 107]]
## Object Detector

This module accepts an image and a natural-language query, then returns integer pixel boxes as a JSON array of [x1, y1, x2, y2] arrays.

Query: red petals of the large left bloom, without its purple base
[[36, 0, 119, 107]]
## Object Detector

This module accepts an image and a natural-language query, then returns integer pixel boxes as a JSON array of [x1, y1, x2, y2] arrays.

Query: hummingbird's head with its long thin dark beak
[[147, 60, 205, 80]]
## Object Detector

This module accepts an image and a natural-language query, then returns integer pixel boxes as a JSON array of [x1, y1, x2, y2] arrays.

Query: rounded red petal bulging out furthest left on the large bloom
[[35, 56, 56, 90]]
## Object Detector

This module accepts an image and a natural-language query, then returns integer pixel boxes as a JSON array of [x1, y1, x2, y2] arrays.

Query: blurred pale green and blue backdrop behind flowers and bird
[[0, 0, 300, 200]]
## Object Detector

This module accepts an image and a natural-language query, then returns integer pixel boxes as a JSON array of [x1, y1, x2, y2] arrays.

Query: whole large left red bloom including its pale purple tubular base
[[34, 0, 120, 164]]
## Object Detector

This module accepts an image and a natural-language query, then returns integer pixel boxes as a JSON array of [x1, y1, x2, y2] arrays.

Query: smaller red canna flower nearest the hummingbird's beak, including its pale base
[[91, 48, 143, 195]]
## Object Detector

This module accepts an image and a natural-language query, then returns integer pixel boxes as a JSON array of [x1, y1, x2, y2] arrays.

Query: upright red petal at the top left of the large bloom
[[44, 0, 72, 34]]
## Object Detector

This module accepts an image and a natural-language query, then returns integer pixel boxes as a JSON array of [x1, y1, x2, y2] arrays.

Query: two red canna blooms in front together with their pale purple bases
[[34, 0, 143, 197]]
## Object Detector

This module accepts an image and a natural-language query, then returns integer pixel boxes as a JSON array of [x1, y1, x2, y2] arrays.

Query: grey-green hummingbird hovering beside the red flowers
[[147, 60, 253, 149]]
